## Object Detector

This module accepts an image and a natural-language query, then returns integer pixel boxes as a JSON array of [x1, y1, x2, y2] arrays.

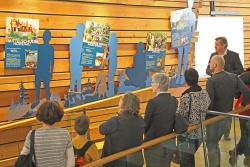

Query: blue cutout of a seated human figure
[[124, 42, 147, 88]]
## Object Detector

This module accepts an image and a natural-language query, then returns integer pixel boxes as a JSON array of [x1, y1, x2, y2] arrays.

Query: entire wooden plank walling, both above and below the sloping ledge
[[0, 0, 250, 167]]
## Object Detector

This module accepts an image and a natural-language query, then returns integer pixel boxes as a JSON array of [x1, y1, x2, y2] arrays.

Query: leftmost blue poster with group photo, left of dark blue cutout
[[5, 17, 39, 69]]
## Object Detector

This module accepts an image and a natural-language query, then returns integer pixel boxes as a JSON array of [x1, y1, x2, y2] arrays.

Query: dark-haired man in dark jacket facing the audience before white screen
[[206, 37, 244, 140]]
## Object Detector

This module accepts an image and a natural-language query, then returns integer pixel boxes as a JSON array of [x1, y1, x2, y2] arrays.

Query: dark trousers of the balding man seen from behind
[[206, 118, 228, 167]]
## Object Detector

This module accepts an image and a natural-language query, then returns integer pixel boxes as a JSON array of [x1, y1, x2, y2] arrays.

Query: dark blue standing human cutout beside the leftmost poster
[[33, 30, 54, 107]]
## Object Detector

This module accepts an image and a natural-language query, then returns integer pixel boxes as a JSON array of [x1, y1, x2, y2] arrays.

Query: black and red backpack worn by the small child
[[74, 141, 94, 167]]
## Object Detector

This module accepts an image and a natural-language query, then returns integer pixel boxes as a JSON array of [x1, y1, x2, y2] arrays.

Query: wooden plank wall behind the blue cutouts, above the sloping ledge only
[[0, 0, 201, 122]]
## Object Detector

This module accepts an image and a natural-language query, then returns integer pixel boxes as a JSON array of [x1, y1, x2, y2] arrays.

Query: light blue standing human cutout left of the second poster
[[69, 23, 85, 92]]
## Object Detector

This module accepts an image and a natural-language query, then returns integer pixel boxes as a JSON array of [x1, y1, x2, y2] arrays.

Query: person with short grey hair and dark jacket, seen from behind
[[144, 73, 177, 167]]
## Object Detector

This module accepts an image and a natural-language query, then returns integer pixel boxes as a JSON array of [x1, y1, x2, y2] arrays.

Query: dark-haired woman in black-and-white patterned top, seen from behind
[[177, 68, 210, 167]]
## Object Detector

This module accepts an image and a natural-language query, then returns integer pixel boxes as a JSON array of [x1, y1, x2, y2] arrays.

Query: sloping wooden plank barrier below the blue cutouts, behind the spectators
[[0, 87, 185, 167]]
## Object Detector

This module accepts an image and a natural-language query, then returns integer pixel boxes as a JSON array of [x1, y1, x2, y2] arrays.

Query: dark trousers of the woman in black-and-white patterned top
[[180, 138, 201, 167]]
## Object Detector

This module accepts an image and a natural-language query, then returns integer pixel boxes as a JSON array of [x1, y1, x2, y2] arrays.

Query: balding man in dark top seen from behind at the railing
[[206, 55, 249, 167]]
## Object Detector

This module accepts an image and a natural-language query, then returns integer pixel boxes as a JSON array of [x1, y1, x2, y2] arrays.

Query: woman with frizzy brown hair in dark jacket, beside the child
[[100, 93, 145, 167]]
